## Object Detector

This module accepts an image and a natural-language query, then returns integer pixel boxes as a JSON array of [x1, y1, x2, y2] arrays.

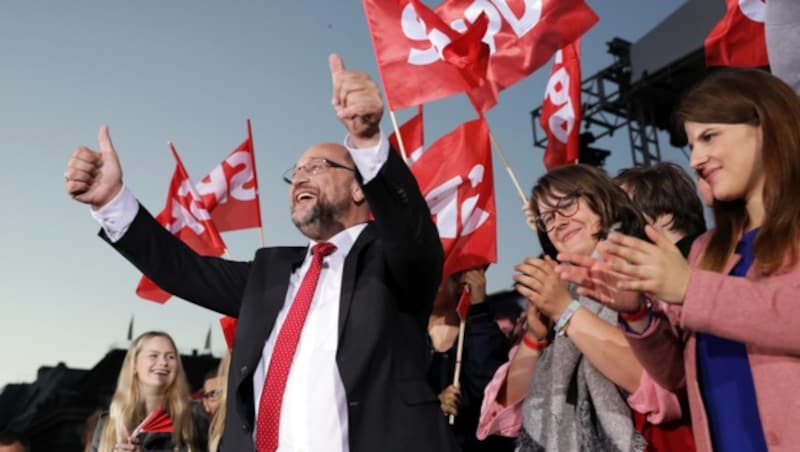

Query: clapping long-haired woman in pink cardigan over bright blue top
[[560, 69, 800, 451]]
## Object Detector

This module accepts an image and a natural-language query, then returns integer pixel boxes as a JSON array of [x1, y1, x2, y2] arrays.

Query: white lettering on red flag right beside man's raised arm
[[425, 165, 489, 239]]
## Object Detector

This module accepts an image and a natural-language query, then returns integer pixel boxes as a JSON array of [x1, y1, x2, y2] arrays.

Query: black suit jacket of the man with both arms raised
[[101, 150, 456, 452]]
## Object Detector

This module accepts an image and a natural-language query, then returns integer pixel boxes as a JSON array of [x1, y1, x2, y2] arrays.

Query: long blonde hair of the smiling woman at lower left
[[98, 331, 195, 452]]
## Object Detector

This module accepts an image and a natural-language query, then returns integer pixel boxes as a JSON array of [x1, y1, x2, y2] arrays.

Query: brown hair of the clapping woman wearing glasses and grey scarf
[[530, 165, 646, 259]]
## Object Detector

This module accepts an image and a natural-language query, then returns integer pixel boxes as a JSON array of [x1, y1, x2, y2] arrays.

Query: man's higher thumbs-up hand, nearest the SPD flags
[[328, 53, 383, 147]]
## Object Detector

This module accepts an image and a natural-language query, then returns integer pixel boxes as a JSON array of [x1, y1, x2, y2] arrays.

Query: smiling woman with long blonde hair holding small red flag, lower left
[[90, 331, 204, 452]]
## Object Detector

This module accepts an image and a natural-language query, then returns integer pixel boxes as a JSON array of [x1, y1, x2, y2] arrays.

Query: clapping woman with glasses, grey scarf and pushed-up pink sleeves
[[478, 165, 674, 451]]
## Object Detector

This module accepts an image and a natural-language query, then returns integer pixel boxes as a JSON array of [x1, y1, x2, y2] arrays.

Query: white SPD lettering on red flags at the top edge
[[400, 0, 540, 66]]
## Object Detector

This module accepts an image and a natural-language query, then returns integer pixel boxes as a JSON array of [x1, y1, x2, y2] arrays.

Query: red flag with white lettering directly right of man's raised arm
[[411, 118, 497, 278]]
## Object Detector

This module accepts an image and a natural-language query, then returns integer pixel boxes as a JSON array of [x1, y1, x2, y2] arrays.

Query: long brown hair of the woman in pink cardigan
[[676, 69, 800, 274]]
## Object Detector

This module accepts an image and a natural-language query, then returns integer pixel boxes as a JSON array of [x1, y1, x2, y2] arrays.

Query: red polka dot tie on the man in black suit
[[256, 242, 336, 452]]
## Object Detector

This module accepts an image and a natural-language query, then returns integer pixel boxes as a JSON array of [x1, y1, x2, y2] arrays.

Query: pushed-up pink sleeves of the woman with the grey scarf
[[477, 346, 681, 440]]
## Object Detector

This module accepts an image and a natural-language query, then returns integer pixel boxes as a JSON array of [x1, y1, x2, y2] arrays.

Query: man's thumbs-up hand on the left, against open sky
[[64, 126, 122, 209]]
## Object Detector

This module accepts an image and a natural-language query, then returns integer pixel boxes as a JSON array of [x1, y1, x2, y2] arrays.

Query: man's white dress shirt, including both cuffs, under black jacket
[[92, 134, 389, 452]]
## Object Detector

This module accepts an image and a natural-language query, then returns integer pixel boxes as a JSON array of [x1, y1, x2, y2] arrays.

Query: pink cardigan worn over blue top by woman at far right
[[627, 233, 800, 451]]
